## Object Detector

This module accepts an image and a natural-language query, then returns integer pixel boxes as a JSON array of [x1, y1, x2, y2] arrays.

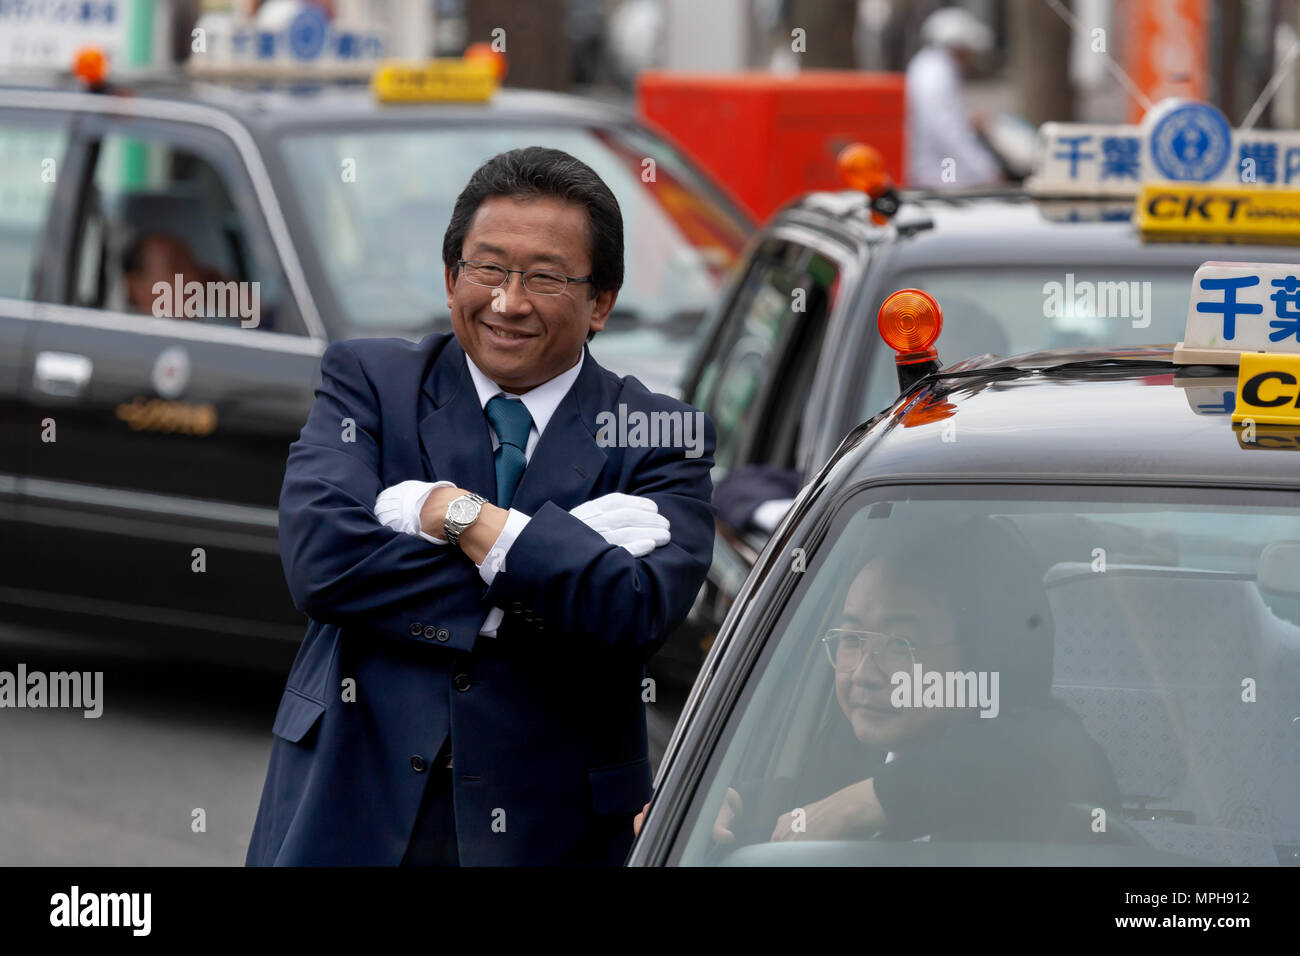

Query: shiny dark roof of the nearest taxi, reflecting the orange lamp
[[820, 338, 1300, 489]]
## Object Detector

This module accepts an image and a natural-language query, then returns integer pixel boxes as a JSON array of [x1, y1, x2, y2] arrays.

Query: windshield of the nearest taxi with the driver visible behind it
[[673, 485, 1300, 866]]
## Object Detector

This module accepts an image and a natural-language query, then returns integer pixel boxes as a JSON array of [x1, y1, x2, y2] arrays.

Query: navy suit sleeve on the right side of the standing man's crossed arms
[[485, 410, 716, 661]]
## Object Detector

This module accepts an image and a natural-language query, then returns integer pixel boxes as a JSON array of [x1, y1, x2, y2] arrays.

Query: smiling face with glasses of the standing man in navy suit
[[446, 196, 618, 394]]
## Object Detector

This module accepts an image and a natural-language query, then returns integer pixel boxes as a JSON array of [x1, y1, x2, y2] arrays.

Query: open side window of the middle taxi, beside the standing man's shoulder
[[696, 243, 839, 479]]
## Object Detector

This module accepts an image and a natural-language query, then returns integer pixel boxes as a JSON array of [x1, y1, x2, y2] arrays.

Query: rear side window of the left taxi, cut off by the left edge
[[0, 113, 68, 299]]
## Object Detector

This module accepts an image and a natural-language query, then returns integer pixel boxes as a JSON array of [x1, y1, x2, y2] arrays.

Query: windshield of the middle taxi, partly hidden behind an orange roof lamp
[[857, 265, 1193, 421]]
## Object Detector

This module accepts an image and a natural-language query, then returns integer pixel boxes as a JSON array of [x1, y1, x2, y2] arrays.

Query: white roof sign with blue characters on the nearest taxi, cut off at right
[[1174, 263, 1300, 365]]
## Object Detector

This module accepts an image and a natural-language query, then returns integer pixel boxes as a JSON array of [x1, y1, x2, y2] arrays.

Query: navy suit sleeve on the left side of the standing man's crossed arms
[[280, 342, 486, 650]]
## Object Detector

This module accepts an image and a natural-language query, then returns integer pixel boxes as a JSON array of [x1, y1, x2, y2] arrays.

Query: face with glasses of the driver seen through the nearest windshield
[[835, 558, 959, 750]]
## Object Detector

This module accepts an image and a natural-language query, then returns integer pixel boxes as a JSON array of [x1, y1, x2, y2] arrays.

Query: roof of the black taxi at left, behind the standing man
[[0, 73, 636, 130]]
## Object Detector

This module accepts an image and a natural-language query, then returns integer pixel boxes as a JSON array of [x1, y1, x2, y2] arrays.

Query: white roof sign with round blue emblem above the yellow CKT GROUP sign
[[1024, 99, 1300, 196]]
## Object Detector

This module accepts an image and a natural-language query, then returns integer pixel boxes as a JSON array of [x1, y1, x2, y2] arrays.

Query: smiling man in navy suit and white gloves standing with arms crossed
[[247, 147, 715, 865]]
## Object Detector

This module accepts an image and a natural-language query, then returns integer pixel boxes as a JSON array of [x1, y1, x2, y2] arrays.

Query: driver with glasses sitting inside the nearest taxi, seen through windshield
[[712, 519, 1119, 844]]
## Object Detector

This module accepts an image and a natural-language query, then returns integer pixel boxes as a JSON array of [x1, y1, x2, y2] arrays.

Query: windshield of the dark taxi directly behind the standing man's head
[[282, 125, 750, 350]]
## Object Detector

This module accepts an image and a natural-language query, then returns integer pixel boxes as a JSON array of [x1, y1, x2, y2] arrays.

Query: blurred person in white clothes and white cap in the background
[[906, 7, 1002, 187]]
